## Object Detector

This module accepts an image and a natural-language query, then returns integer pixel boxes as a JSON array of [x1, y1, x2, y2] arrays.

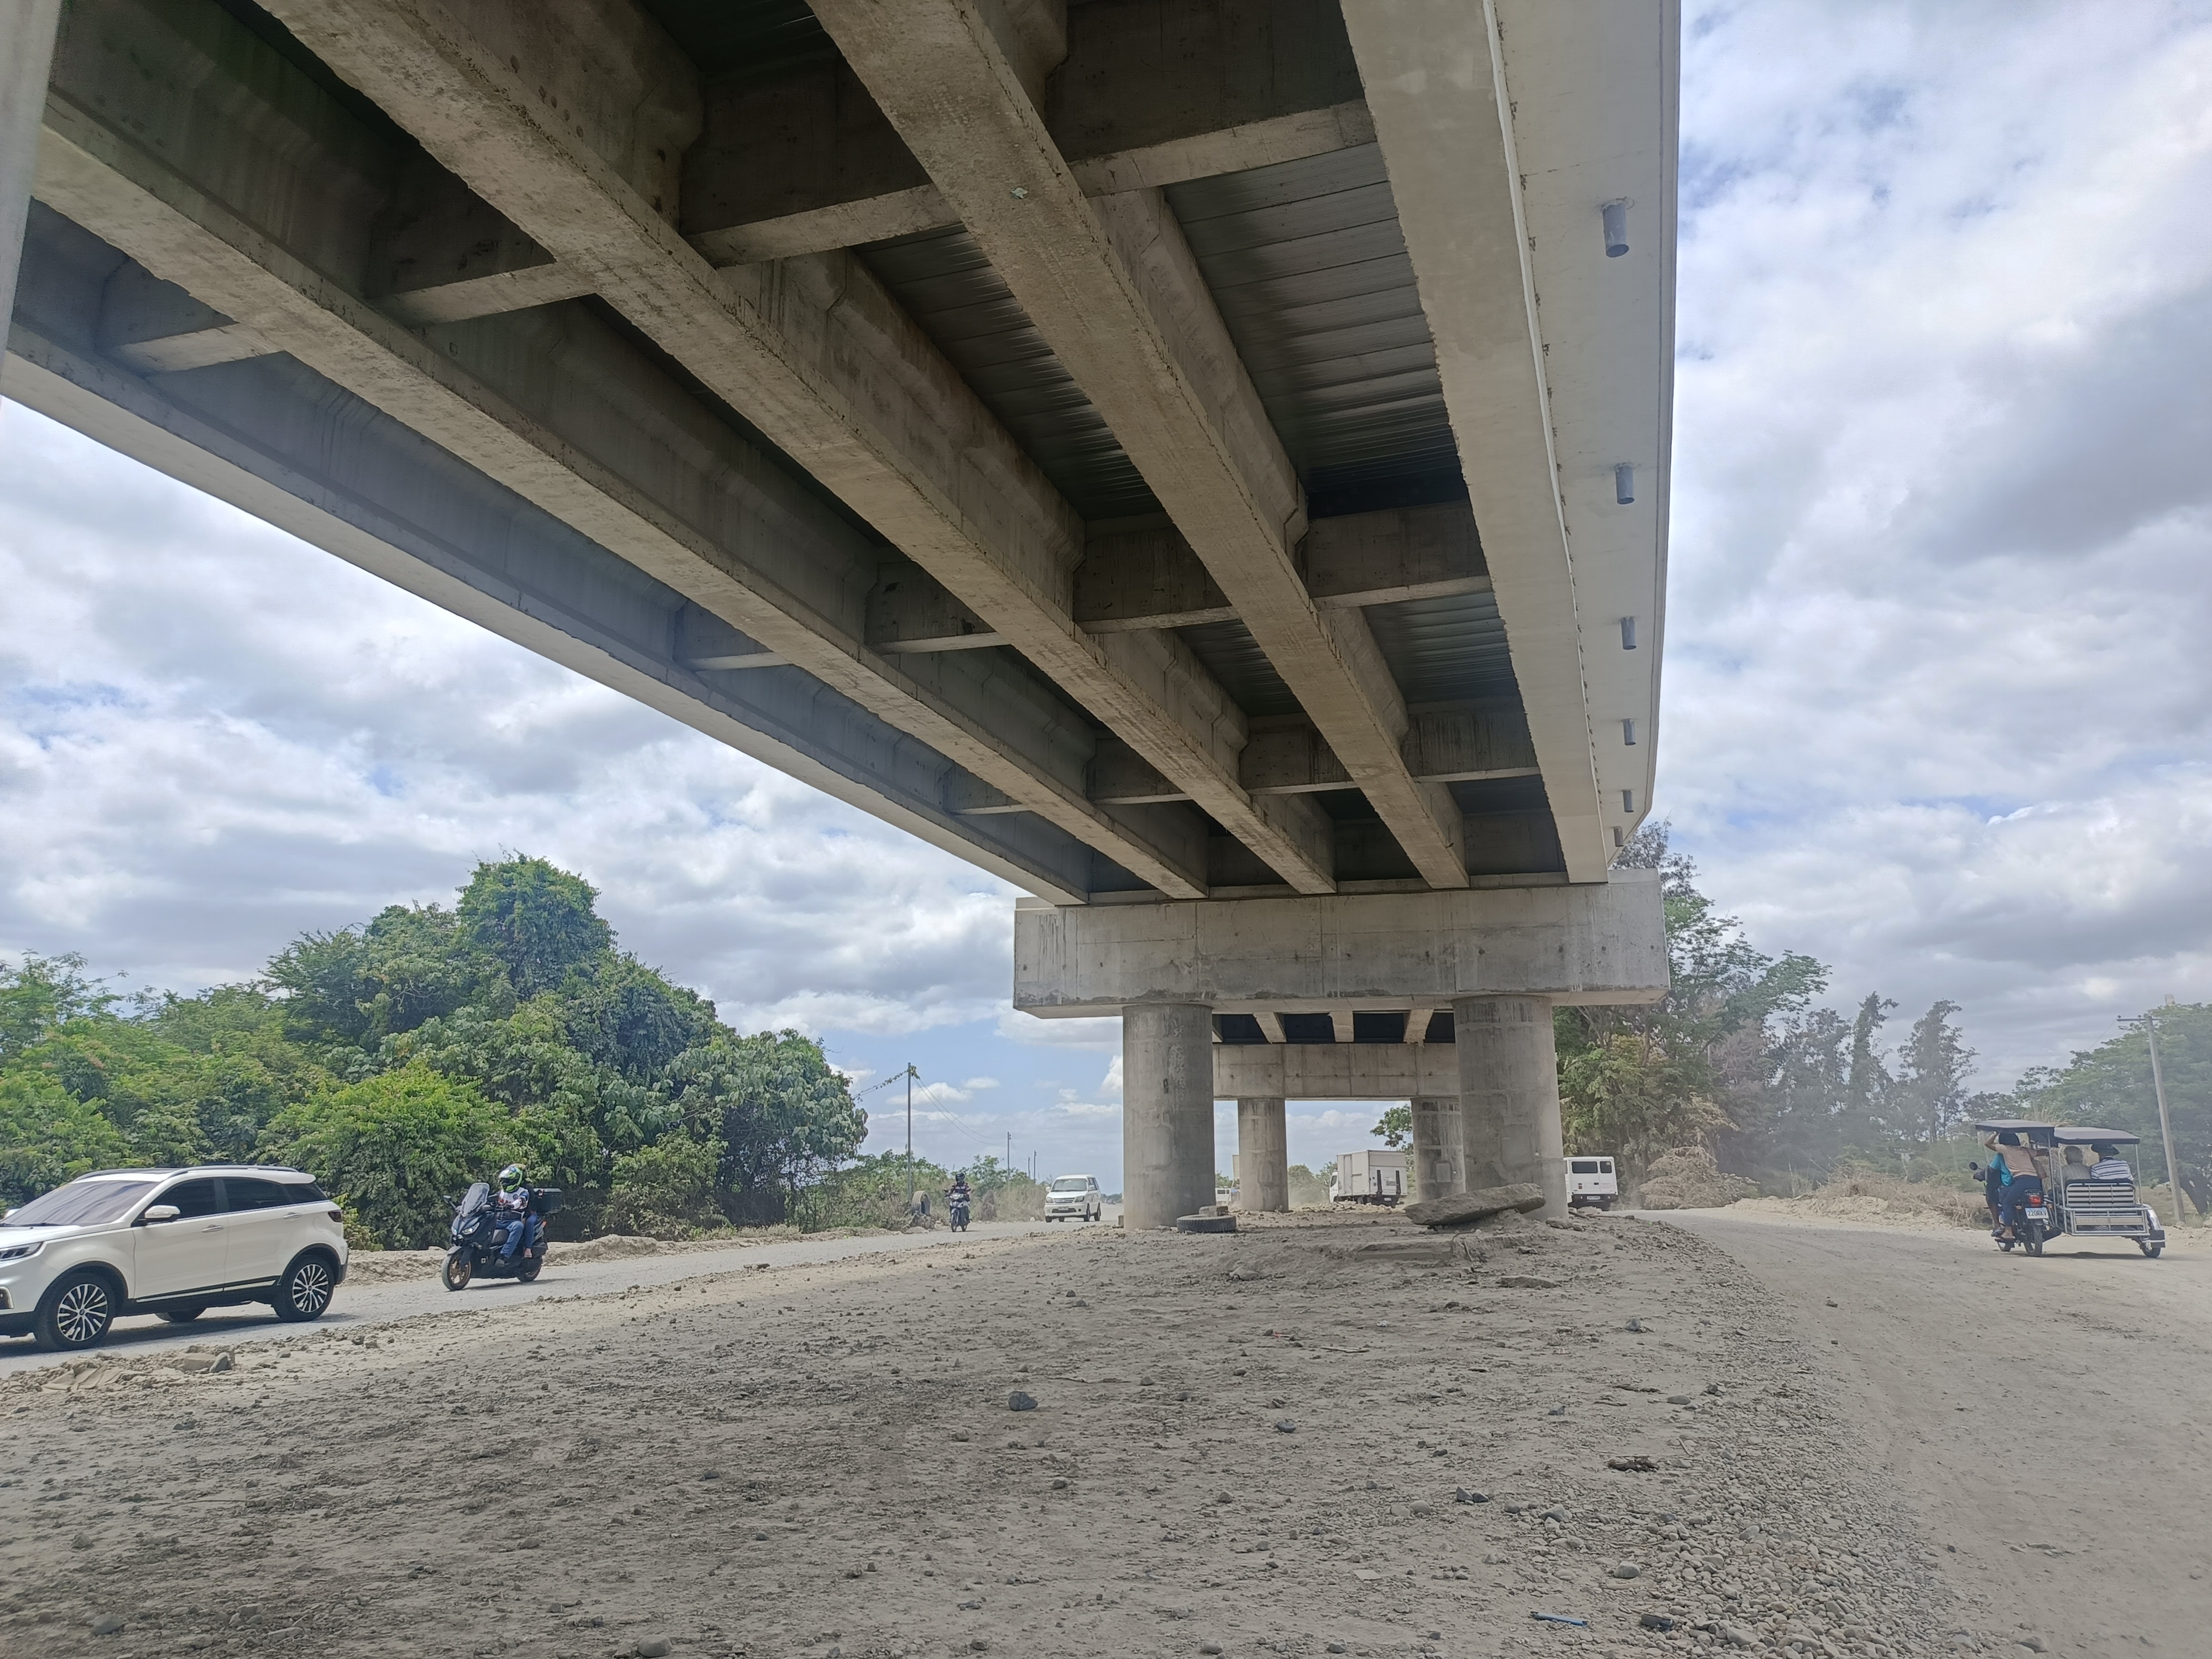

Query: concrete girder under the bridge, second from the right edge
[[814, 0, 1467, 887]]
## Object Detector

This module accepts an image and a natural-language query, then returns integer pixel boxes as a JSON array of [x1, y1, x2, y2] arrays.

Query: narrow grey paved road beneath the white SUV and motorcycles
[[0, 1206, 1088, 1376]]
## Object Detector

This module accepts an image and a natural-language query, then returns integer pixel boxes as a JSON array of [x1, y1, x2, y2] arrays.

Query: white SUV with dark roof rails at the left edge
[[0, 1164, 345, 1347]]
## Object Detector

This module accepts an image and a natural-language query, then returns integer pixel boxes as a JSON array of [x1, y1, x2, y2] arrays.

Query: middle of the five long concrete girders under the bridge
[[270, 0, 1334, 896]]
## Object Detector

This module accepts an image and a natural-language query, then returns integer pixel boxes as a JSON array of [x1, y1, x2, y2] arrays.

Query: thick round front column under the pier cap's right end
[[1451, 998, 1566, 1217]]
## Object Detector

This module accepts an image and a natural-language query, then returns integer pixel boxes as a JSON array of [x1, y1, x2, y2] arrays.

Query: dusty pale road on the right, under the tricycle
[[1663, 1210, 2212, 1655]]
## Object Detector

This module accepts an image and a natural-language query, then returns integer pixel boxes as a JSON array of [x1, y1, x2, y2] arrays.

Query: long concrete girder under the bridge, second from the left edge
[[38, 7, 1206, 898]]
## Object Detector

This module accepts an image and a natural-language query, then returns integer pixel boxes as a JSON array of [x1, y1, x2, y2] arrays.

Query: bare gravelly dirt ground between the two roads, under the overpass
[[0, 1214, 1949, 1659]]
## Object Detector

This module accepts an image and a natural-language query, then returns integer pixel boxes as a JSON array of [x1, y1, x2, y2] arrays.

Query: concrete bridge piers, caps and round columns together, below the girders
[[1013, 869, 1668, 1228]]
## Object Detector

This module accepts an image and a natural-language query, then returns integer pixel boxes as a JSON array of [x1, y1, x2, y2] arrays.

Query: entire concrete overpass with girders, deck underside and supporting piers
[[0, 0, 1679, 1225]]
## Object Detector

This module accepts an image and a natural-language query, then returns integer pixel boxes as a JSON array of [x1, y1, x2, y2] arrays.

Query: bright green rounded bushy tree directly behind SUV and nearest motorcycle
[[263, 1064, 522, 1250]]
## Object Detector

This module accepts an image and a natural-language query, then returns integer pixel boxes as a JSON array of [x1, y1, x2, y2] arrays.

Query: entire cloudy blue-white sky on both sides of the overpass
[[0, 0, 2212, 1186]]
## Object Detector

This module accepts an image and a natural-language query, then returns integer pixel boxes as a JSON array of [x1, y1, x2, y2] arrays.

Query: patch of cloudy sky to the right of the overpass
[[1659, 2, 2212, 1084]]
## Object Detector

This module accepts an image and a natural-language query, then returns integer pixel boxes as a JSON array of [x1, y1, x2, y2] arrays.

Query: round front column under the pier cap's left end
[[1121, 1002, 1214, 1228]]
